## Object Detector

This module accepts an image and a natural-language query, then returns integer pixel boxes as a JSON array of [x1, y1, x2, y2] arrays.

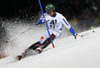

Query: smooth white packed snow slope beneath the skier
[[0, 28, 100, 68]]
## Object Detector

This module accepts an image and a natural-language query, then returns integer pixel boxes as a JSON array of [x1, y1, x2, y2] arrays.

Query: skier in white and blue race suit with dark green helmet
[[17, 3, 78, 60]]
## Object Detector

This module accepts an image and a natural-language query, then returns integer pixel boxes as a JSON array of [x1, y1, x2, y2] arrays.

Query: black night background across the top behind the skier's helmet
[[0, 0, 100, 18]]
